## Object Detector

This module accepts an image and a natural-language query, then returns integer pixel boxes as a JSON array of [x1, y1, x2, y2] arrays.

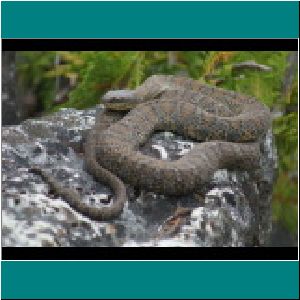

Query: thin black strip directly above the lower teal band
[[2, 247, 298, 261]]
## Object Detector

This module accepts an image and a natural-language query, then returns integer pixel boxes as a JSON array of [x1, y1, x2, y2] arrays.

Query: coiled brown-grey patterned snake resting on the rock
[[32, 75, 271, 221]]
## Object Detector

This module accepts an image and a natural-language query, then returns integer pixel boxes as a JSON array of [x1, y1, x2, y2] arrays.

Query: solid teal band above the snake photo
[[1, 1, 299, 38]]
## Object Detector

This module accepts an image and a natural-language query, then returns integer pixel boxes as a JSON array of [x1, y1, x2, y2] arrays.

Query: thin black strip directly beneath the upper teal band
[[2, 39, 298, 51]]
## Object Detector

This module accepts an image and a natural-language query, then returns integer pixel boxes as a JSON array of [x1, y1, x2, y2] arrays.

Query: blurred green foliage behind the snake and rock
[[17, 51, 298, 233]]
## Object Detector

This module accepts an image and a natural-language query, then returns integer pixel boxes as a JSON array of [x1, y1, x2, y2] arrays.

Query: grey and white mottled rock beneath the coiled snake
[[2, 106, 277, 247]]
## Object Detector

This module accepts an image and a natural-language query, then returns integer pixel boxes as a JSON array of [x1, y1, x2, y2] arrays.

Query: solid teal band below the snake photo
[[2, 261, 299, 299]]
